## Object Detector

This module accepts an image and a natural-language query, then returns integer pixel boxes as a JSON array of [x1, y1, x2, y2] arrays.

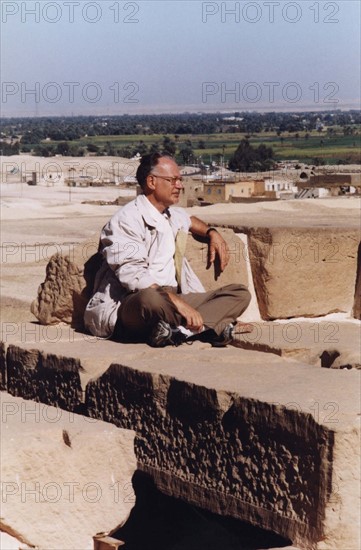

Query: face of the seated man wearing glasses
[[148, 157, 183, 212]]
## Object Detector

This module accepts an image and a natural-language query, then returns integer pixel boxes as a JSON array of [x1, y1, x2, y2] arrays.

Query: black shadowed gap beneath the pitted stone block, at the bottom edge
[[112, 471, 291, 550]]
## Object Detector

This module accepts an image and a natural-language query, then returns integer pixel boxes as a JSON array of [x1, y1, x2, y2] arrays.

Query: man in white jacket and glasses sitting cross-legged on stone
[[84, 153, 250, 347]]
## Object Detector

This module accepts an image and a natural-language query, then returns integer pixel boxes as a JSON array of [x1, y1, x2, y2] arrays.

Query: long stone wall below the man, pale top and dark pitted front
[[1, 341, 360, 550]]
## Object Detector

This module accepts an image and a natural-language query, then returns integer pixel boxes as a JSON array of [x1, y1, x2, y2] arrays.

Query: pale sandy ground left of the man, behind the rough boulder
[[0, 183, 134, 322]]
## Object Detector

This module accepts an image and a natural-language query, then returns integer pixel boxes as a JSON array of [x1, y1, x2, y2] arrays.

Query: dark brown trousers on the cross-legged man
[[114, 285, 251, 339]]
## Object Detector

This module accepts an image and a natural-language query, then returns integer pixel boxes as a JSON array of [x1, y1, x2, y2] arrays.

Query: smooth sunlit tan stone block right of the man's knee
[[249, 227, 360, 319]]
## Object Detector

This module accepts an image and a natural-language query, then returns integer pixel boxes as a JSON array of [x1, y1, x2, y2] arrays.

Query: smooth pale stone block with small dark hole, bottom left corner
[[0, 393, 136, 550]]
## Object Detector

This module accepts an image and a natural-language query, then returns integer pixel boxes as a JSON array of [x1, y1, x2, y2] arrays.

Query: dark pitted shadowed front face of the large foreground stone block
[[86, 365, 333, 544]]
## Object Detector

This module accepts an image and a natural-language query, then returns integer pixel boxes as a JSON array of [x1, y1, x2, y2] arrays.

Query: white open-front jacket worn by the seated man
[[84, 195, 204, 338]]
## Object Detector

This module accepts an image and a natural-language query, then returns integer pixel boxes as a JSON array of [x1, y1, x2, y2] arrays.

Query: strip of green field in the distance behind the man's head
[[41, 128, 361, 164]]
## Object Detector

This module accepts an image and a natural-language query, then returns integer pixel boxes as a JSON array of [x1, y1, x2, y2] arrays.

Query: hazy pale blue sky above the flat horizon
[[1, 0, 360, 116]]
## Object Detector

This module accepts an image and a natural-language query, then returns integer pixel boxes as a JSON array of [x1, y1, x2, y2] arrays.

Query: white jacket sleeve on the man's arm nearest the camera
[[100, 212, 156, 292]]
